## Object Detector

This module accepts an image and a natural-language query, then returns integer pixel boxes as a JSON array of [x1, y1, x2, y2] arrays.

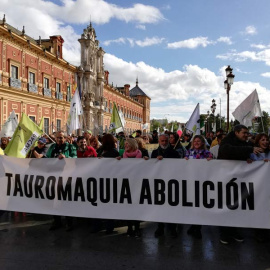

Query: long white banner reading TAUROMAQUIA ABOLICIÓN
[[0, 156, 270, 228]]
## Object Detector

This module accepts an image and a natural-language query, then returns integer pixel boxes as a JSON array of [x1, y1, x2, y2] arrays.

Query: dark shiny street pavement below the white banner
[[0, 212, 270, 270]]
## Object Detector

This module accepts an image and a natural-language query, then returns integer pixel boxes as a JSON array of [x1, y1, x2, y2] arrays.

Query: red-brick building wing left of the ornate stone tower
[[0, 17, 76, 133]]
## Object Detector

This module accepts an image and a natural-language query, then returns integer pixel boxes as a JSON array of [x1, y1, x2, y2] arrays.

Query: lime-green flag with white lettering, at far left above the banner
[[5, 113, 43, 158]]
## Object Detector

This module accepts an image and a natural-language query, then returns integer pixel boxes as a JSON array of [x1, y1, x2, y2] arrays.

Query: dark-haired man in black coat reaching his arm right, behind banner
[[218, 125, 263, 245]]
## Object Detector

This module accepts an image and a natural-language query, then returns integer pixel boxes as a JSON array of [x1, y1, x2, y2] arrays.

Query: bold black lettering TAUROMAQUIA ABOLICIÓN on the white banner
[[5, 173, 255, 210]]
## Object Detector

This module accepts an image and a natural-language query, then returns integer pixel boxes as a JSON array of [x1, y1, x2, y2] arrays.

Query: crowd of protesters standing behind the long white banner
[[0, 125, 270, 244]]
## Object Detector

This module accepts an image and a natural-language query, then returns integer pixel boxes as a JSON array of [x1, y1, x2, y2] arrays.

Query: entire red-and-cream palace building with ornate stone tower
[[0, 17, 151, 134]]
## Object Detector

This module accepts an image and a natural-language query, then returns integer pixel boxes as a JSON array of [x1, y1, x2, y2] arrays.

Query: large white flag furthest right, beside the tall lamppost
[[232, 89, 261, 127]]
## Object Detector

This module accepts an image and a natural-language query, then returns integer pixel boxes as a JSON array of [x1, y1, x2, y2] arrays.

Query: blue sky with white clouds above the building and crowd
[[0, 0, 270, 122]]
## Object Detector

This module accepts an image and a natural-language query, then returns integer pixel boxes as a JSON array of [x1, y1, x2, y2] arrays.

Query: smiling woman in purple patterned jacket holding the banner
[[185, 135, 213, 239]]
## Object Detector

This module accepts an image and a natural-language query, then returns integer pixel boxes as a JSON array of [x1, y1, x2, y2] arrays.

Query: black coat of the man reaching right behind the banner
[[218, 131, 253, 160]]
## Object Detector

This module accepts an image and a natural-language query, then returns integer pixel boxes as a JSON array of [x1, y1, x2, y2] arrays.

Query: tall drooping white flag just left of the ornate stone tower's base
[[67, 88, 83, 132]]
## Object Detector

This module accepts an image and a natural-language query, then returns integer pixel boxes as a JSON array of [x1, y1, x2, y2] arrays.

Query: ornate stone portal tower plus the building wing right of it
[[78, 23, 151, 134]]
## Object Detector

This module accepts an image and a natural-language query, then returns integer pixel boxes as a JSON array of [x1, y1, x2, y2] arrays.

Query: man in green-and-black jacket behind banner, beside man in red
[[46, 131, 77, 231]]
